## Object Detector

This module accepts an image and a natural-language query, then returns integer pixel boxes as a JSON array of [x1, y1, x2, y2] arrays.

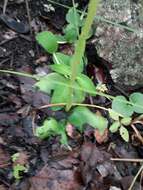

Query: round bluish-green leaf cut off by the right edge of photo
[[130, 92, 143, 113]]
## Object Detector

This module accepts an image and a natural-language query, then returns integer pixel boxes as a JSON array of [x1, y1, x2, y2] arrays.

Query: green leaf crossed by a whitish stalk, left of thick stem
[[53, 52, 71, 65]]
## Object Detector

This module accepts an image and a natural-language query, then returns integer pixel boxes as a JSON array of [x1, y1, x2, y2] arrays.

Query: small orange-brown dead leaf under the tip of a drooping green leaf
[[94, 129, 109, 144]]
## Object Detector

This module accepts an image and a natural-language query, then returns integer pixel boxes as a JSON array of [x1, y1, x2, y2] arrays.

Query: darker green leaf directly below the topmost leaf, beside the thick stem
[[64, 24, 78, 43]]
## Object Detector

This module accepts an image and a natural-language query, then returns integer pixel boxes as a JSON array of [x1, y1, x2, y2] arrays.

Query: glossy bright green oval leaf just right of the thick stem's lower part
[[76, 74, 96, 95]]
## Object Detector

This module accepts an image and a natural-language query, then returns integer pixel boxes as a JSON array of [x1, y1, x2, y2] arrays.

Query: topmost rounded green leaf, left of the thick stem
[[66, 7, 82, 28]]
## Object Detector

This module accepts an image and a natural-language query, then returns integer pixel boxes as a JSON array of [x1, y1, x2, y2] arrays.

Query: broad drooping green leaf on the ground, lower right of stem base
[[69, 106, 108, 133]]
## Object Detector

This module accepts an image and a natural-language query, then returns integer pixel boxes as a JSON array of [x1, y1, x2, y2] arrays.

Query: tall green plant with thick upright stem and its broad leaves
[[35, 0, 104, 144]]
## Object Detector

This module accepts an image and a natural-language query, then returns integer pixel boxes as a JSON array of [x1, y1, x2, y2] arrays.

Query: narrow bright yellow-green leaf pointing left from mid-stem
[[50, 64, 71, 76]]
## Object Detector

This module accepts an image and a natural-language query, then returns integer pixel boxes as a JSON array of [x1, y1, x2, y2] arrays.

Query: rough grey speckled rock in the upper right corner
[[95, 0, 143, 87]]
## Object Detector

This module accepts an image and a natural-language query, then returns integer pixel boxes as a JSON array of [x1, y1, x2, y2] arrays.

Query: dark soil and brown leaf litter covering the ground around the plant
[[0, 0, 143, 190]]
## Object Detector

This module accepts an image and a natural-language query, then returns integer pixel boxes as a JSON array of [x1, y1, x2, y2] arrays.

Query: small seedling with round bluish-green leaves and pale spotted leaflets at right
[[109, 92, 143, 142]]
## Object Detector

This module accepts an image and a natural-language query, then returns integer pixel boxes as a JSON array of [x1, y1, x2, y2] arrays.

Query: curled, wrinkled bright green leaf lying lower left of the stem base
[[36, 118, 67, 144]]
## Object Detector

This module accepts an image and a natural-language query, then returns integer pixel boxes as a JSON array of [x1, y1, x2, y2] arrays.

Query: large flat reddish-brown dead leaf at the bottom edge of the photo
[[30, 157, 82, 190]]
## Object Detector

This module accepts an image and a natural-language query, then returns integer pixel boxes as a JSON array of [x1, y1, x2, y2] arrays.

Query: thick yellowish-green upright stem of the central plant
[[66, 0, 99, 111]]
